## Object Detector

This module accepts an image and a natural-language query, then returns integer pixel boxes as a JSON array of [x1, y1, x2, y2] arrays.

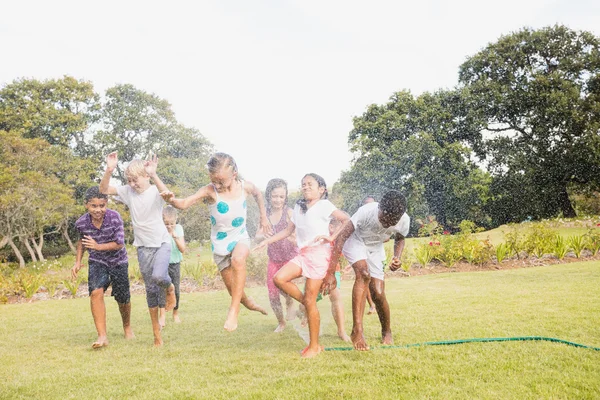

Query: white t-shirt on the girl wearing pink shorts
[[292, 199, 337, 249]]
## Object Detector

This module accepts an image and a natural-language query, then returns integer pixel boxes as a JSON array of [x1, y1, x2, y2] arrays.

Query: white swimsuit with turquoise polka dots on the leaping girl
[[209, 181, 250, 256]]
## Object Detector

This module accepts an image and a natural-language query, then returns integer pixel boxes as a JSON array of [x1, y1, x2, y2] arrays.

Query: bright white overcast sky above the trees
[[0, 0, 600, 189]]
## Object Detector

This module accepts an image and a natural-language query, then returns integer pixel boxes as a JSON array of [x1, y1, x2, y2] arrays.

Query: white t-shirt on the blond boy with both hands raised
[[117, 185, 171, 247]]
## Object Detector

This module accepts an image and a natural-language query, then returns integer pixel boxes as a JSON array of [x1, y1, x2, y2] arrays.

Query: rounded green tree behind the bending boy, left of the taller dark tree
[[334, 91, 489, 230]]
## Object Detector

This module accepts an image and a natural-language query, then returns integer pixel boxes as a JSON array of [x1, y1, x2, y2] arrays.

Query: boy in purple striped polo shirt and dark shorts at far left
[[71, 186, 135, 349]]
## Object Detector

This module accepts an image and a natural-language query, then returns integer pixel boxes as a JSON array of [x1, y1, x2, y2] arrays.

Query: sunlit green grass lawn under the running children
[[0, 262, 600, 399]]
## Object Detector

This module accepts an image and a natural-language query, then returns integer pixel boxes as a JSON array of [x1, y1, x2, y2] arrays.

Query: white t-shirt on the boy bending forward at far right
[[349, 202, 410, 246]]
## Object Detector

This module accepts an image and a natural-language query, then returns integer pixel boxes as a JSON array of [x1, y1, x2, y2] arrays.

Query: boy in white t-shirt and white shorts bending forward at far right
[[320, 190, 410, 350]]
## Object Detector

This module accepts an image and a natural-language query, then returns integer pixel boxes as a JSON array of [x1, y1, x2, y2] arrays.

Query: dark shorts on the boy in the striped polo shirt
[[88, 262, 131, 304]]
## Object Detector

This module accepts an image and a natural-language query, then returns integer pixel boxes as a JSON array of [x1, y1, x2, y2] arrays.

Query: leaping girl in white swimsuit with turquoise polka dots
[[161, 153, 271, 332]]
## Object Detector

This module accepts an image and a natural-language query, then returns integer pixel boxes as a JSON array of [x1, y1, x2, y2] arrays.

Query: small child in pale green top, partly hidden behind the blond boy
[[158, 206, 185, 328]]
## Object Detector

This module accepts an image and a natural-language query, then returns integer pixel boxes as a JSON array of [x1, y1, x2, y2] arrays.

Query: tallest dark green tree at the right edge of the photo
[[459, 25, 600, 223]]
